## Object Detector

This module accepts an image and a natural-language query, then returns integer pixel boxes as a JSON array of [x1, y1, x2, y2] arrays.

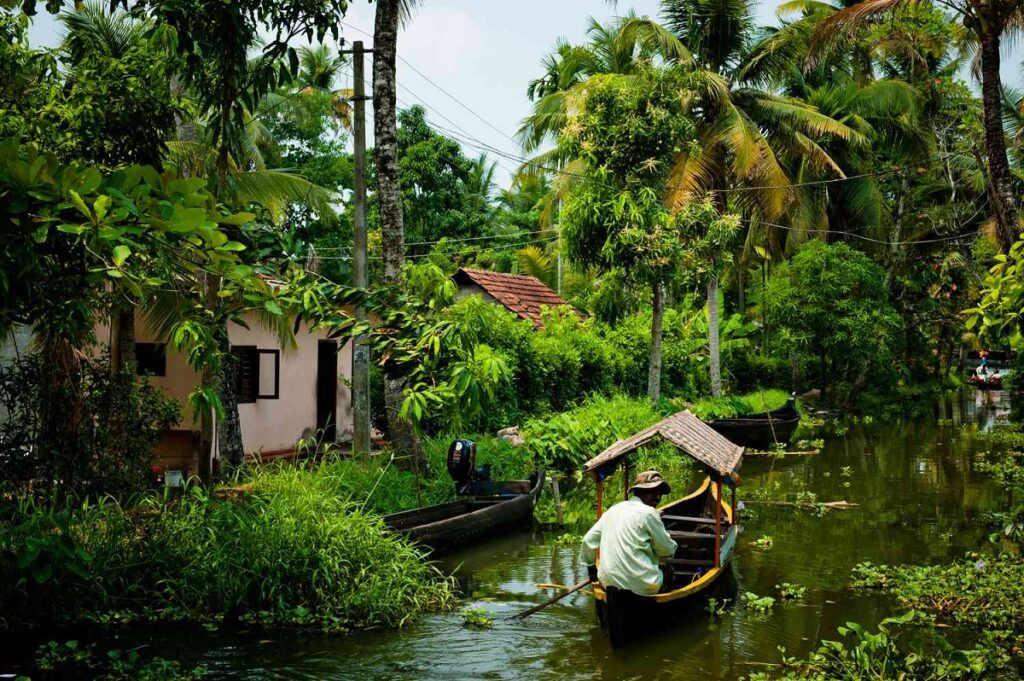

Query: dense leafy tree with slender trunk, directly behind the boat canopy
[[560, 68, 693, 401]]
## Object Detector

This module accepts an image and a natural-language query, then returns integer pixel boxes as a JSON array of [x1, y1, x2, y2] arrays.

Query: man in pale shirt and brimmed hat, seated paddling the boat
[[583, 471, 676, 596]]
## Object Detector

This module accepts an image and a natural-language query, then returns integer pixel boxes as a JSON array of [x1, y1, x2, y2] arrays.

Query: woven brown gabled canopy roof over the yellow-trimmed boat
[[583, 410, 743, 478]]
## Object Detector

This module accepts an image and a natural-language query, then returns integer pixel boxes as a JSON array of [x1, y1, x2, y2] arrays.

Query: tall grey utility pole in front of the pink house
[[343, 41, 373, 457]]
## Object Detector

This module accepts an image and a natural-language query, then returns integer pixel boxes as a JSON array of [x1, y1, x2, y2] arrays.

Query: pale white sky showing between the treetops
[[24, 0, 1022, 186]]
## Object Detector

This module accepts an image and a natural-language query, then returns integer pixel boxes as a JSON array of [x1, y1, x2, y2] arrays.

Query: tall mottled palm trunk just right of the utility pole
[[374, 0, 427, 471]]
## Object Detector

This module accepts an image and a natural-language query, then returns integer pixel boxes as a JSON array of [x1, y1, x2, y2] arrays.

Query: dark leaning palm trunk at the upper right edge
[[978, 29, 1020, 253]]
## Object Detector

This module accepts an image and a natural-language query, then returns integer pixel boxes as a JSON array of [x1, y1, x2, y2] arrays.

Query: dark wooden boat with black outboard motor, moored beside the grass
[[384, 440, 544, 552]]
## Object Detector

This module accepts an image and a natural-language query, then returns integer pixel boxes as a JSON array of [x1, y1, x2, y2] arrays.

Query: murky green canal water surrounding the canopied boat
[[16, 391, 1009, 680]]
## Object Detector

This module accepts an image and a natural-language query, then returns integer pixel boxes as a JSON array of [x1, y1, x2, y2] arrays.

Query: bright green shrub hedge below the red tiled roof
[[387, 280, 755, 432]]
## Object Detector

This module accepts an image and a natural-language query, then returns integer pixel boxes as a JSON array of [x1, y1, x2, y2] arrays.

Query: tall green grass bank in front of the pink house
[[0, 465, 454, 631]]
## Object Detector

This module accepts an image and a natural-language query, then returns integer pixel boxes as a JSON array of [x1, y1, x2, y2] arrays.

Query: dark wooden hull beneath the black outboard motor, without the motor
[[384, 471, 544, 553]]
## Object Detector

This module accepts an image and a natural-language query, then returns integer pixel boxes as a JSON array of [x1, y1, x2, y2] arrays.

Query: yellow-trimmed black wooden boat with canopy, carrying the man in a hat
[[584, 412, 743, 647]]
